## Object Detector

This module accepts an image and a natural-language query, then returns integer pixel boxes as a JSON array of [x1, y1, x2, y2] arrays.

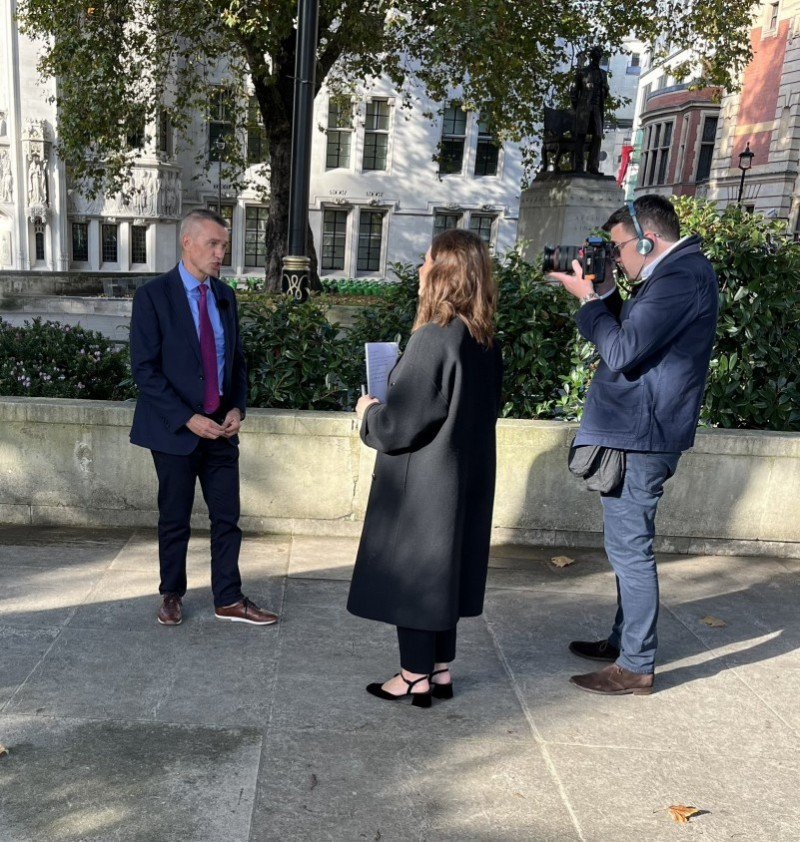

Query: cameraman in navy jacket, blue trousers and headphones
[[550, 194, 718, 695]]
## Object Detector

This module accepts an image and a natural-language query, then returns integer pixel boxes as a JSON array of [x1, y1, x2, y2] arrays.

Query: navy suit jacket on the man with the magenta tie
[[130, 266, 247, 456]]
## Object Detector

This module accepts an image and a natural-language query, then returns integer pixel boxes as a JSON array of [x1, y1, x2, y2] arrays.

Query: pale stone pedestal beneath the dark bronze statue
[[517, 172, 625, 263]]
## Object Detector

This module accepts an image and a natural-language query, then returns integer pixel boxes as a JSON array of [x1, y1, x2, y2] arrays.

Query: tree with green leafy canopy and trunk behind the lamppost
[[17, 0, 756, 288]]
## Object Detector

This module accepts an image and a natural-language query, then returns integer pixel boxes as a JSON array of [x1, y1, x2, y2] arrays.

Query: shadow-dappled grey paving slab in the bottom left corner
[[0, 715, 262, 842]]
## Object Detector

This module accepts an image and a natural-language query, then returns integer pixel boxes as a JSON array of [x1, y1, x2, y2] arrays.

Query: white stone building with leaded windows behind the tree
[[0, 2, 638, 278]]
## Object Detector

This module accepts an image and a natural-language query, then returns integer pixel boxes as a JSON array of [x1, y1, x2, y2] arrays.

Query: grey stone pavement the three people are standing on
[[0, 527, 800, 842]]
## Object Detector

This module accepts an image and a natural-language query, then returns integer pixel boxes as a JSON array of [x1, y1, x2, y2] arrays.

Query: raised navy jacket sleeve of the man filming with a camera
[[575, 264, 699, 372]]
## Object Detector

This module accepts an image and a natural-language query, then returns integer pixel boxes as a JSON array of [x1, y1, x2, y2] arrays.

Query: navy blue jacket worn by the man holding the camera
[[575, 237, 719, 452]]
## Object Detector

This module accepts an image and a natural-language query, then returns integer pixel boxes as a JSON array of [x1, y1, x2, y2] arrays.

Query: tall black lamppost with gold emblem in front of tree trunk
[[281, 0, 319, 301]]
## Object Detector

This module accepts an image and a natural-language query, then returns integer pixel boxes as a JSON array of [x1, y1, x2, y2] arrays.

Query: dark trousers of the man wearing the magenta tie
[[151, 438, 242, 607]]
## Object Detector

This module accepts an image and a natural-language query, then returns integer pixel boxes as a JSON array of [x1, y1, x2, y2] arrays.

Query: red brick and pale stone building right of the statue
[[626, 0, 800, 232]]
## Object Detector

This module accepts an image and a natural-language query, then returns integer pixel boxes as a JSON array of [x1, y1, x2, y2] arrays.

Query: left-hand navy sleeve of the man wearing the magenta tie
[[130, 285, 194, 432]]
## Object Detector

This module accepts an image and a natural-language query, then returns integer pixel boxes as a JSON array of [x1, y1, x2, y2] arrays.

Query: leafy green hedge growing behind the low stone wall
[[0, 197, 800, 431]]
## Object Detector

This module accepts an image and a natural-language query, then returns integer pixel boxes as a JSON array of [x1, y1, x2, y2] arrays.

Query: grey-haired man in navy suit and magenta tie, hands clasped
[[130, 209, 278, 626]]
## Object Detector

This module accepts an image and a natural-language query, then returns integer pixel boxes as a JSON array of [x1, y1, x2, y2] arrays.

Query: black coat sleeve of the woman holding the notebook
[[361, 336, 450, 454]]
